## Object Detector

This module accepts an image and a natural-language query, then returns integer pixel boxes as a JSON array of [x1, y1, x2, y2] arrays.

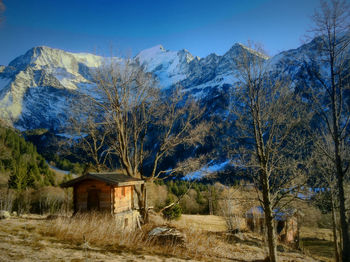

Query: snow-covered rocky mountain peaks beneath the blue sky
[[0, 37, 346, 131]]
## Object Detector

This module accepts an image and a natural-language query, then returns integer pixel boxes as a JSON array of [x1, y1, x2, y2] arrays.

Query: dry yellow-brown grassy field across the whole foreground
[[0, 215, 330, 262]]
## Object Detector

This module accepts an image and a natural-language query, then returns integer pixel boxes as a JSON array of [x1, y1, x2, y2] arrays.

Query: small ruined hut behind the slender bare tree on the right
[[246, 206, 298, 243]]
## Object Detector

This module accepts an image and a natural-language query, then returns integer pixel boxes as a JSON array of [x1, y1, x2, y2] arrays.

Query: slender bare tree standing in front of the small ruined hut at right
[[231, 43, 306, 261]]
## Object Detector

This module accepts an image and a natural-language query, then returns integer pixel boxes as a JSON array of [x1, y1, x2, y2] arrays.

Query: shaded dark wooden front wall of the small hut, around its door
[[74, 180, 111, 212]]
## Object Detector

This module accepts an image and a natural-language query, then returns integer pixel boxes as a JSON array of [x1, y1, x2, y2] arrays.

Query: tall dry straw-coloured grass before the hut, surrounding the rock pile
[[42, 214, 263, 261]]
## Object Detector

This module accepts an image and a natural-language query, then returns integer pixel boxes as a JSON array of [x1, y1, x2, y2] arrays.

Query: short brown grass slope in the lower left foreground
[[0, 216, 197, 262]]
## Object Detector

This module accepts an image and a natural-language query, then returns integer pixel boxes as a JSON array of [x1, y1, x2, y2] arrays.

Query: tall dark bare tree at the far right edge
[[312, 0, 350, 262]]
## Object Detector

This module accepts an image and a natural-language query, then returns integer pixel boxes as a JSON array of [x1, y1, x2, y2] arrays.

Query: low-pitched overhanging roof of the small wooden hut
[[61, 172, 144, 187]]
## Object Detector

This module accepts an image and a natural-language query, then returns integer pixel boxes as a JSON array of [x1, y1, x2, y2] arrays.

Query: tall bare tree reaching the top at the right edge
[[307, 0, 350, 261]]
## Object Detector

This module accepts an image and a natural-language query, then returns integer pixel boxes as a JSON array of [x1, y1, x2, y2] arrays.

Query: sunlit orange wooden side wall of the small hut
[[114, 186, 134, 213]]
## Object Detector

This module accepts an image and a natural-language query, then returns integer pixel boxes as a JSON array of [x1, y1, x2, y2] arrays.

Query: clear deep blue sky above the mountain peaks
[[0, 0, 328, 65]]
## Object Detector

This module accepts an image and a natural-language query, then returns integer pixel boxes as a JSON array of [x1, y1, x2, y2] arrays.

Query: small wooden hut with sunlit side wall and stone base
[[61, 172, 144, 229]]
